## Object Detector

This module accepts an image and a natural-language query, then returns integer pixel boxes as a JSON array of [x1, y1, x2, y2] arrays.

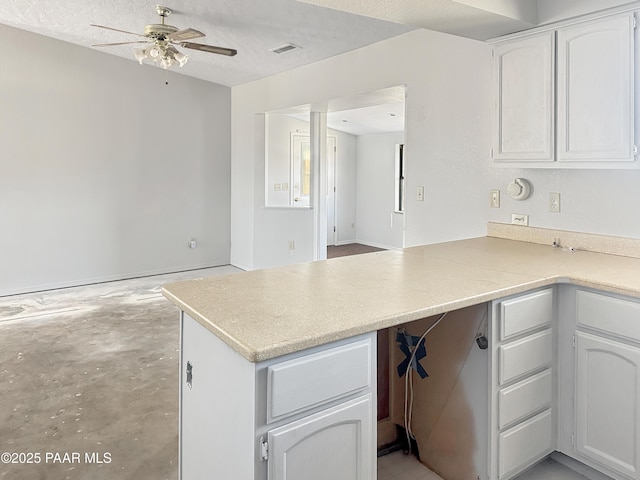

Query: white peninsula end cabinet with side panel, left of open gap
[[179, 312, 377, 480]]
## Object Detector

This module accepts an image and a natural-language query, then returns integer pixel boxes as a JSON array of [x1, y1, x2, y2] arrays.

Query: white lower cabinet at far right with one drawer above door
[[565, 288, 640, 479]]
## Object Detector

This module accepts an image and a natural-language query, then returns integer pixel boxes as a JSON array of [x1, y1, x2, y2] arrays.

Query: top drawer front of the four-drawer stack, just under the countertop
[[500, 288, 553, 340]]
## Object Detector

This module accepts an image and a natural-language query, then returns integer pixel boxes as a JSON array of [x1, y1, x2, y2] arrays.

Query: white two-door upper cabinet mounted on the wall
[[492, 11, 639, 168]]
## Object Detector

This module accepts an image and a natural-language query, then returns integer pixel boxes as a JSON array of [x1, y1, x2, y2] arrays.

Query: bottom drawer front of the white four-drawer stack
[[498, 410, 553, 478]]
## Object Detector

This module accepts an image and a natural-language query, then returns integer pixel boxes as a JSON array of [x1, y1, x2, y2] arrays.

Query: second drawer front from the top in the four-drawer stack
[[498, 328, 553, 385]]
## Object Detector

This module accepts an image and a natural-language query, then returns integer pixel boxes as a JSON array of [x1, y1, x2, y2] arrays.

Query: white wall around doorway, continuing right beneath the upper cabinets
[[231, 10, 640, 268]]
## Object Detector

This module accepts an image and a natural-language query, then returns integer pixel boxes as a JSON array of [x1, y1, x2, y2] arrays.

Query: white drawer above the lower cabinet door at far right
[[576, 290, 640, 341]]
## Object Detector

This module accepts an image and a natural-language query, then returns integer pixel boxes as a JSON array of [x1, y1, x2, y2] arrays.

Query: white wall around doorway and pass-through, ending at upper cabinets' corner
[[231, 30, 490, 268]]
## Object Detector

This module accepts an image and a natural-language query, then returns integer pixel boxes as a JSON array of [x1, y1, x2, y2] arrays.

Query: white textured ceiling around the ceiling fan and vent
[[0, 0, 415, 86]]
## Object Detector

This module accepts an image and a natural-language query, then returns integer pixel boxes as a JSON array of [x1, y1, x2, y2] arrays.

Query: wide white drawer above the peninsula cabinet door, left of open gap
[[267, 339, 372, 423]]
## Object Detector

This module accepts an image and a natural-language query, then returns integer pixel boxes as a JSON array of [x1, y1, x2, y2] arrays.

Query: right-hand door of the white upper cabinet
[[557, 13, 634, 162]]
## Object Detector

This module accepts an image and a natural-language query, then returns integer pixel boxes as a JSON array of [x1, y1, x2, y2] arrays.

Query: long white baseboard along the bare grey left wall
[[0, 263, 230, 297]]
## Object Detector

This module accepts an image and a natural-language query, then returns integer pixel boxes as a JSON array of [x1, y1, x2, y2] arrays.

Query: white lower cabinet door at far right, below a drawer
[[576, 332, 640, 479]]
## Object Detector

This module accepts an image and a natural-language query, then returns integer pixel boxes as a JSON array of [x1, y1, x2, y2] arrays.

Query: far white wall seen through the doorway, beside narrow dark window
[[357, 132, 408, 248]]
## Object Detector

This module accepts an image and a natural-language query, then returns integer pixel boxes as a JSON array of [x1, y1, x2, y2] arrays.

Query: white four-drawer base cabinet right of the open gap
[[489, 288, 555, 480]]
